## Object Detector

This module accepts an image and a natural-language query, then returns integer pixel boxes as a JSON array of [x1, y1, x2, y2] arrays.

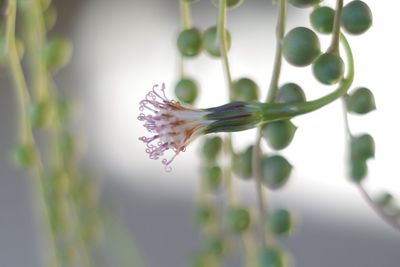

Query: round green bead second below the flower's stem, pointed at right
[[262, 155, 293, 189]]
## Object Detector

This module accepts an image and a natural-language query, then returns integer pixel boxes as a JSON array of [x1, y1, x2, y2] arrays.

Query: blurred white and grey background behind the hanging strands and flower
[[0, 0, 400, 267]]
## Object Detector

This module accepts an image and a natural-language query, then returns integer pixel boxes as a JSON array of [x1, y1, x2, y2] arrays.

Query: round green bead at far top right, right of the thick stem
[[341, 0, 372, 35]]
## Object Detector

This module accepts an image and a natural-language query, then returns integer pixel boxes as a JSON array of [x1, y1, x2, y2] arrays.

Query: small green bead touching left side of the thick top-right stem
[[310, 6, 335, 33]]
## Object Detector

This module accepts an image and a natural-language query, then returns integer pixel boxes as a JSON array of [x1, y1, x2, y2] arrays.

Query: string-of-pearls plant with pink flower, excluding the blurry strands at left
[[139, 0, 400, 267]]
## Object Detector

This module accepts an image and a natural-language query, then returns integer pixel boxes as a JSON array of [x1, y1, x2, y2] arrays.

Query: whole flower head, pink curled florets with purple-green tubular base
[[138, 84, 262, 171]]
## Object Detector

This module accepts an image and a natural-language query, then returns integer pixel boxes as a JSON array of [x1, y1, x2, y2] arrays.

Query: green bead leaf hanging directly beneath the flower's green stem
[[262, 120, 297, 150]]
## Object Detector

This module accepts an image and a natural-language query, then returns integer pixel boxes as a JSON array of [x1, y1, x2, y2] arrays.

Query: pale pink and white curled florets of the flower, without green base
[[138, 83, 212, 171]]
